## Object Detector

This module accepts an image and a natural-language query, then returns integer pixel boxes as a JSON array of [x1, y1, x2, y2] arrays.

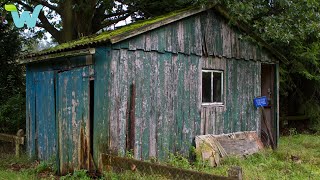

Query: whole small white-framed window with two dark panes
[[202, 70, 223, 105]]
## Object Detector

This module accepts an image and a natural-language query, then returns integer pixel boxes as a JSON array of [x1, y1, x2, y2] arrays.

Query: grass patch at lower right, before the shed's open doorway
[[200, 135, 320, 179]]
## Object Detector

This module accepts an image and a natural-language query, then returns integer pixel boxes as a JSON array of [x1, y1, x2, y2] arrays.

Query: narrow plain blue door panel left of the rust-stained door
[[34, 71, 56, 160]]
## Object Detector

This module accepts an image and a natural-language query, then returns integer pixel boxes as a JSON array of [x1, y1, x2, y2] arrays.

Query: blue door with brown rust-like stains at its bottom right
[[57, 66, 90, 174]]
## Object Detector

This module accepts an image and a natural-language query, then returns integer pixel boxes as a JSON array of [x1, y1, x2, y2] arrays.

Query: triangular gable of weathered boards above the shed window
[[112, 9, 275, 63]]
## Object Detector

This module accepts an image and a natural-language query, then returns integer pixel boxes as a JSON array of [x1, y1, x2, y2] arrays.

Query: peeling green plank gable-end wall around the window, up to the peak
[[101, 7, 276, 159]]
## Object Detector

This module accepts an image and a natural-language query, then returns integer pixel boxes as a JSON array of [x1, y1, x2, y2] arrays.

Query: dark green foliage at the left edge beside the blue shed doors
[[0, 24, 25, 134]]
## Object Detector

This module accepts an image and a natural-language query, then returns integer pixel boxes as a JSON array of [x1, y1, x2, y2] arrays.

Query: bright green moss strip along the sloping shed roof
[[35, 7, 193, 56]]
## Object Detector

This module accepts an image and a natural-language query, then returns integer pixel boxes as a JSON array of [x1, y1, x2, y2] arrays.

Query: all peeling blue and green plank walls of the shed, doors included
[[26, 7, 276, 171]]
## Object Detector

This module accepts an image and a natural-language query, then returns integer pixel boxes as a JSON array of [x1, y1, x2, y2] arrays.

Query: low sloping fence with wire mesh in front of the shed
[[101, 154, 242, 180]]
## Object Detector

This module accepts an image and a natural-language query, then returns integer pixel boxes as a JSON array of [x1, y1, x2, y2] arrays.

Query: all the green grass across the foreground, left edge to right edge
[[0, 135, 320, 180]]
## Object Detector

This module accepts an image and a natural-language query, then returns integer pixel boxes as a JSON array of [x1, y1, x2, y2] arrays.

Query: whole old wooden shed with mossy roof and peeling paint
[[21, 6, 282, 173]]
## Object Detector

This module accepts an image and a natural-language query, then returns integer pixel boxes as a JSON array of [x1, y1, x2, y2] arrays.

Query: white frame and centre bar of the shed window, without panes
[[201, 69, 224, 106]]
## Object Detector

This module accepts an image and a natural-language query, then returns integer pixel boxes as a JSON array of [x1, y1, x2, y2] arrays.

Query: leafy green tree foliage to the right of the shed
[[212, 0, 320, 129]]
